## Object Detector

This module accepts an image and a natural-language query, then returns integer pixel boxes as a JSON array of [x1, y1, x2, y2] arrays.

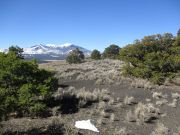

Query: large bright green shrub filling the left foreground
[[0, 46, 58, 117]]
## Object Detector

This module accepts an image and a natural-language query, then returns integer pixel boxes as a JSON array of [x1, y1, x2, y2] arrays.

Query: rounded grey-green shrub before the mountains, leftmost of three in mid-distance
[[66, 48, 84, 64]]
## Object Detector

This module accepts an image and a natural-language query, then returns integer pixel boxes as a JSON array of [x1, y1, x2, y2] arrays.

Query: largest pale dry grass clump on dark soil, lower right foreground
[[126, 103, 160, 123]]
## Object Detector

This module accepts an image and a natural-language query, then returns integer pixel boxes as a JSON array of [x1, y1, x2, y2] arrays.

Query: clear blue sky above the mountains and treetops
[[0, 0, 180, 51]]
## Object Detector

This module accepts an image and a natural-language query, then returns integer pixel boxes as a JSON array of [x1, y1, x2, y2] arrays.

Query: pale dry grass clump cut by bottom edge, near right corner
[[151, 123, 169, 135]]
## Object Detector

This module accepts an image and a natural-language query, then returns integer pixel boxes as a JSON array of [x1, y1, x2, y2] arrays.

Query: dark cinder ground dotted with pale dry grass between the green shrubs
[[3, 59, 180, 135]]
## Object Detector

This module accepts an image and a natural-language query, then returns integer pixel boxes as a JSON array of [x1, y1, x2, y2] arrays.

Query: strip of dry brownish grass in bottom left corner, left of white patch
[[0, 117, 77, 135]]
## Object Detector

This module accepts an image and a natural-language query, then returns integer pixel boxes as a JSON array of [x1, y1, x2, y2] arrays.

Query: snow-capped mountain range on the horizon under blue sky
[[0, 43, 91, 60]]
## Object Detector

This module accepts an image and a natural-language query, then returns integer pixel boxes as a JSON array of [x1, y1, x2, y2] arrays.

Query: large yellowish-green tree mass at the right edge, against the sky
[[119, 33, 180, 84]]
